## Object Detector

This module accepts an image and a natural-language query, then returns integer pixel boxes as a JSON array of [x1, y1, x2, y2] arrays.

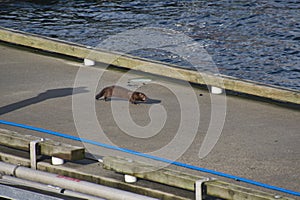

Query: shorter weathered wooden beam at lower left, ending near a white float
[[0, 129, 85, 160]]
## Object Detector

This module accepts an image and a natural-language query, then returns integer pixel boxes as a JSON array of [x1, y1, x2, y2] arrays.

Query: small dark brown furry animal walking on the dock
[[96, 85, 148, 104]]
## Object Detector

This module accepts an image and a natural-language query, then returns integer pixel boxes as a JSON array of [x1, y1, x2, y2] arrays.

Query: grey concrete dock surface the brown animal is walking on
[[0, 44, 300, 197]]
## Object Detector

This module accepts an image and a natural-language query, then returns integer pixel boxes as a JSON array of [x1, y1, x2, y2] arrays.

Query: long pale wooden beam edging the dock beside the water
[[0, 27, 300, 104]]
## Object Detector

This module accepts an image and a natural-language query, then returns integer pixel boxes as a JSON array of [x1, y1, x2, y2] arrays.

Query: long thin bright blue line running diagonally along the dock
[[0, 120, 300, 196]]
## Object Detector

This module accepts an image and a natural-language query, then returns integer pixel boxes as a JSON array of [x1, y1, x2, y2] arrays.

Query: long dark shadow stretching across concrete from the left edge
[[0, 87, 88, 115]]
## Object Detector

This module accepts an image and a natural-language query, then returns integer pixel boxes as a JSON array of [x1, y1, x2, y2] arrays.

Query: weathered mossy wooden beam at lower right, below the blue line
[[103, 156, 291, 200]]
